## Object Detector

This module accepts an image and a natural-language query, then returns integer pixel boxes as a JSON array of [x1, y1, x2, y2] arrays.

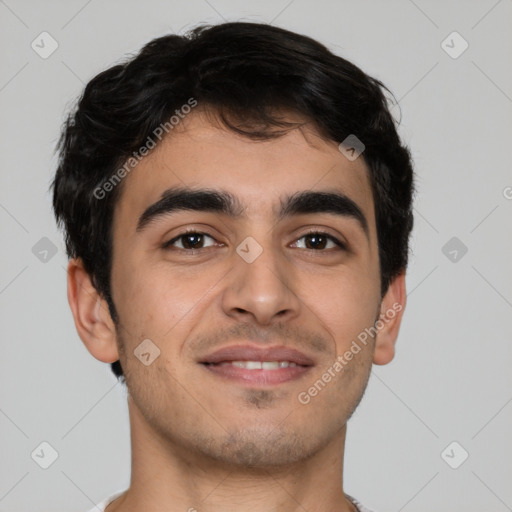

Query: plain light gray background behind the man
[[0, 0, 512, 512]]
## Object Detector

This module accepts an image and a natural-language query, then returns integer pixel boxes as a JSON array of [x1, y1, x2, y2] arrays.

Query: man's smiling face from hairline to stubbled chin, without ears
[[108, 113, 390, 466]]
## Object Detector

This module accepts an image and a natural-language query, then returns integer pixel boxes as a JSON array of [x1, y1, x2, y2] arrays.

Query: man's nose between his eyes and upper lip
[[222, 240, 301, 325]]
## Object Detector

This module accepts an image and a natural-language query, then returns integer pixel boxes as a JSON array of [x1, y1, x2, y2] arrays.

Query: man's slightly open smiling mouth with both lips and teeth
[[200, 345, 314, 386]]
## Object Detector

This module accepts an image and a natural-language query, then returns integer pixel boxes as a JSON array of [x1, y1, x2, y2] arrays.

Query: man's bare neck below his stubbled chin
[[106, 396, 355, 512]]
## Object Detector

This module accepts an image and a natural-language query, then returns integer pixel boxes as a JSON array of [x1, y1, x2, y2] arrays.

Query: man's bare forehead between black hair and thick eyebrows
[[115, 112, 374, 232]]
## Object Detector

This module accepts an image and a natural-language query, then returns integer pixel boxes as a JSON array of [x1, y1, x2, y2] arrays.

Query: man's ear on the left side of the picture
[[68, 259, 119, 363]]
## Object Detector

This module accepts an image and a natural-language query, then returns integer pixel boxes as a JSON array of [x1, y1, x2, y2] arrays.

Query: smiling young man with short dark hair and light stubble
[[52, 23, 414, 512]]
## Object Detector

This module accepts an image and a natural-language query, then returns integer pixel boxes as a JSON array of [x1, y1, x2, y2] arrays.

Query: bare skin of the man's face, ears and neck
[[68, 111, 406, 512]]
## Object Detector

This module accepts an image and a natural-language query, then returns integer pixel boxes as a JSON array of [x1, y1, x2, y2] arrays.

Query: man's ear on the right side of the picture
[[373, 271, 407, 364]]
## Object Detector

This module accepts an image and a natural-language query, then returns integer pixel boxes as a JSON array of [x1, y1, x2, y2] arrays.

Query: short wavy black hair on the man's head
[[51, 22, 414, 379]]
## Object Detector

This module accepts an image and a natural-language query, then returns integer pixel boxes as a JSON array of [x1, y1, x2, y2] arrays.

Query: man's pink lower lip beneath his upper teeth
[[203, 364, 312, 386]]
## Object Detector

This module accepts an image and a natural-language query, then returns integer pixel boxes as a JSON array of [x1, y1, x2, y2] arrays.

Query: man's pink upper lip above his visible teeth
[[200, 345, 315, 366]]
